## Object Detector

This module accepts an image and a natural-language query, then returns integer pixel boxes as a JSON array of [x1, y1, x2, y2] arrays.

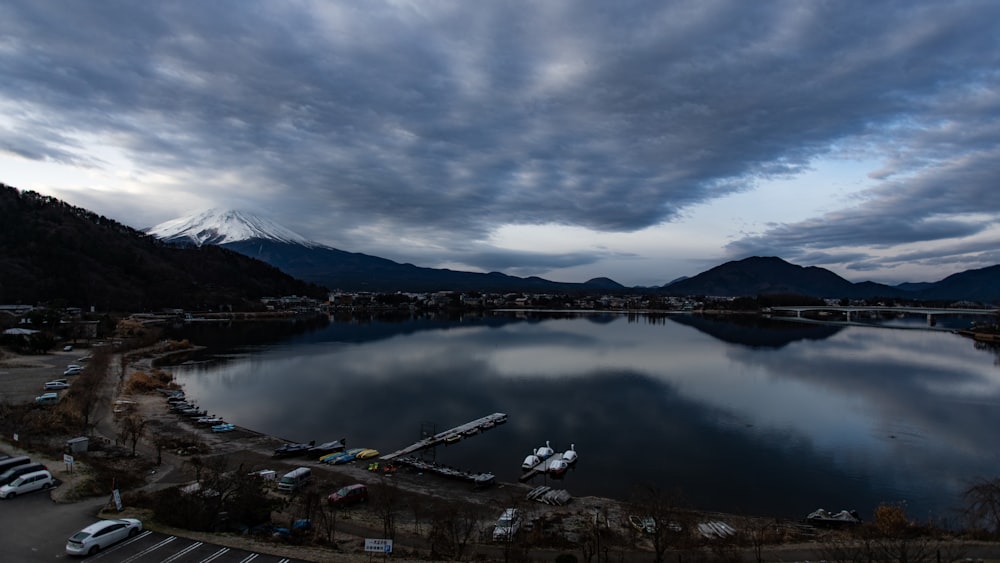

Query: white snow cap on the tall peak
[[146, 209, 322, 248]]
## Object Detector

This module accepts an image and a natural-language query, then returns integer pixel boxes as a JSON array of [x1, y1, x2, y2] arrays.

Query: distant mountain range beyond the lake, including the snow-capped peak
[[147, 210, 1000, 302]]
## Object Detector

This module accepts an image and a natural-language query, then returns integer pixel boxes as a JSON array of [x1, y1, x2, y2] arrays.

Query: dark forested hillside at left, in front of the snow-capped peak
[[0, 184, 326, 311]]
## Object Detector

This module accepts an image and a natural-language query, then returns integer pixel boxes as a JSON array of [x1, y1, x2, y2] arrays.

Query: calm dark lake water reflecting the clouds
[[166, 313, 1000, 521]]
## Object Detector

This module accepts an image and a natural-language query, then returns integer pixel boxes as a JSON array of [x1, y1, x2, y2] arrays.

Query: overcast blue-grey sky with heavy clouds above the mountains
[[0, 0, 1000, 285]]
